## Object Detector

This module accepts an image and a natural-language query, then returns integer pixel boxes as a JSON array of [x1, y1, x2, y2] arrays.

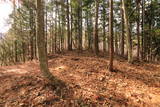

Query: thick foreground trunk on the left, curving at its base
[[36, 0, 55, 81]]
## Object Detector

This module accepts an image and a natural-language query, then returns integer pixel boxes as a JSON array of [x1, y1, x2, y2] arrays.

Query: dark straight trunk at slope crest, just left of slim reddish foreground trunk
[[94, 0, 99, 55]]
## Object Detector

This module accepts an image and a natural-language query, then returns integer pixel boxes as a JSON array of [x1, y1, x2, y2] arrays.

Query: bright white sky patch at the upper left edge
[[0, 0, 12, 33]]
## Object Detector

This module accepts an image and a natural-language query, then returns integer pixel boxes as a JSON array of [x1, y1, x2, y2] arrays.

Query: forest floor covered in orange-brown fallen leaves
[[0, 52, 160, 107]]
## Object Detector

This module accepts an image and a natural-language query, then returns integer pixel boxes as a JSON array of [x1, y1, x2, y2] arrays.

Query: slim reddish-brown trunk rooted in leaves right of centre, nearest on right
[[109, 0, 114, 72]]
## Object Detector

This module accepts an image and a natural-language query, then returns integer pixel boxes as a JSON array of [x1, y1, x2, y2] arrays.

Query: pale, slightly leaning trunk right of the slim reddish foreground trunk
[[122, 0, 132, 63]]
